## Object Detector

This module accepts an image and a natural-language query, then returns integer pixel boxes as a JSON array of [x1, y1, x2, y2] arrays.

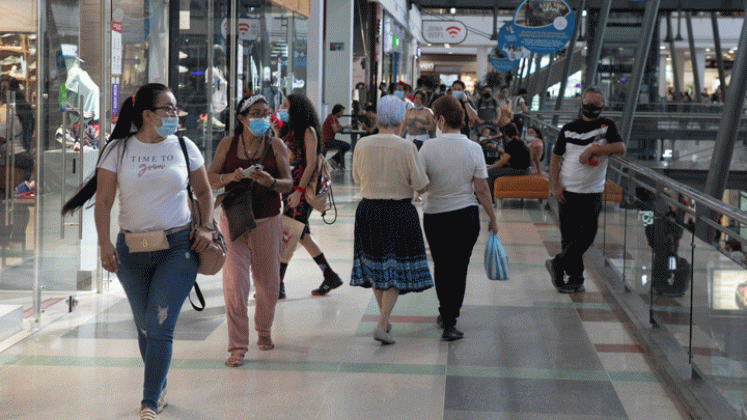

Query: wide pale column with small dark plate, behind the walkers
[[322, 0, 354, 115]]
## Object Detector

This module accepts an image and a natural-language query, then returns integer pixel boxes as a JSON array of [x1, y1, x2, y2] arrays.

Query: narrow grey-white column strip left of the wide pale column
[[306, 1, 326, 115]]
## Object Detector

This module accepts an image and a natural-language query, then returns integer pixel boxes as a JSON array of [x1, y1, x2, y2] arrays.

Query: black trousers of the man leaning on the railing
[[555, 191, 602, 284]]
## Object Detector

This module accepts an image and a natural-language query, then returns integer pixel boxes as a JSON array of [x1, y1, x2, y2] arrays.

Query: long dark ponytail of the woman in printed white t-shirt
[[62, 83, 171, 215]]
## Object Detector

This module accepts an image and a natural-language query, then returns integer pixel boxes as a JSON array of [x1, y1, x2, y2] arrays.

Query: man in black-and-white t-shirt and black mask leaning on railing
[[545, 87, 625, 293]]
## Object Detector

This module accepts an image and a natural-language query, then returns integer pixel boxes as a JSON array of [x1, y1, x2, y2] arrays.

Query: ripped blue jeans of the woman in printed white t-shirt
[[117, 229, 197, 410]]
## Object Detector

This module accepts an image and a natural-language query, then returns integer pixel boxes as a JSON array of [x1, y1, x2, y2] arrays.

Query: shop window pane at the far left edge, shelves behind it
[[0, 27, 37, 332]]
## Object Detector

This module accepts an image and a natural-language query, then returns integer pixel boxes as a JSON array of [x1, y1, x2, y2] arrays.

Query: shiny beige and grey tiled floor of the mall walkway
[[0, 169, 683, 420]]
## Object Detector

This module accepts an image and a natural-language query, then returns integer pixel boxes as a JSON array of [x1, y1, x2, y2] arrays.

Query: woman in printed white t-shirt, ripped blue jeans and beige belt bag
[[63, 83, 213, 419]]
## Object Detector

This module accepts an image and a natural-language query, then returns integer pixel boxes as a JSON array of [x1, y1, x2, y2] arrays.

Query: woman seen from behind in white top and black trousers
[[420, 96, 498, 341]]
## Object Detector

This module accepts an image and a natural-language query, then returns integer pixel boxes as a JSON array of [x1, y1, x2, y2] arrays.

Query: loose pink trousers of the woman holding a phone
[[220, 213, 283, 355]]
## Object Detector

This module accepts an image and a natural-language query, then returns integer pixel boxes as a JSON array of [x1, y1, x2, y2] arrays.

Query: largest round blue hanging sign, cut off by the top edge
[[513, 0, 576, 54]]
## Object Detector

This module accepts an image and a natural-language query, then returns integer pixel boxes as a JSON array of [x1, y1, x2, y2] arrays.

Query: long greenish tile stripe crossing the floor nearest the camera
[[2, 356, 660, 384]]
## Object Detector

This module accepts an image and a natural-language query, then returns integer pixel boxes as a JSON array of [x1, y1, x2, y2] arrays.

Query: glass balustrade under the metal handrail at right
[[597, 162, 747, 412]]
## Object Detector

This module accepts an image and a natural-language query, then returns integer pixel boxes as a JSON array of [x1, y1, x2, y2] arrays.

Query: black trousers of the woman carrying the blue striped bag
[[423, 206, 480, 328]]
